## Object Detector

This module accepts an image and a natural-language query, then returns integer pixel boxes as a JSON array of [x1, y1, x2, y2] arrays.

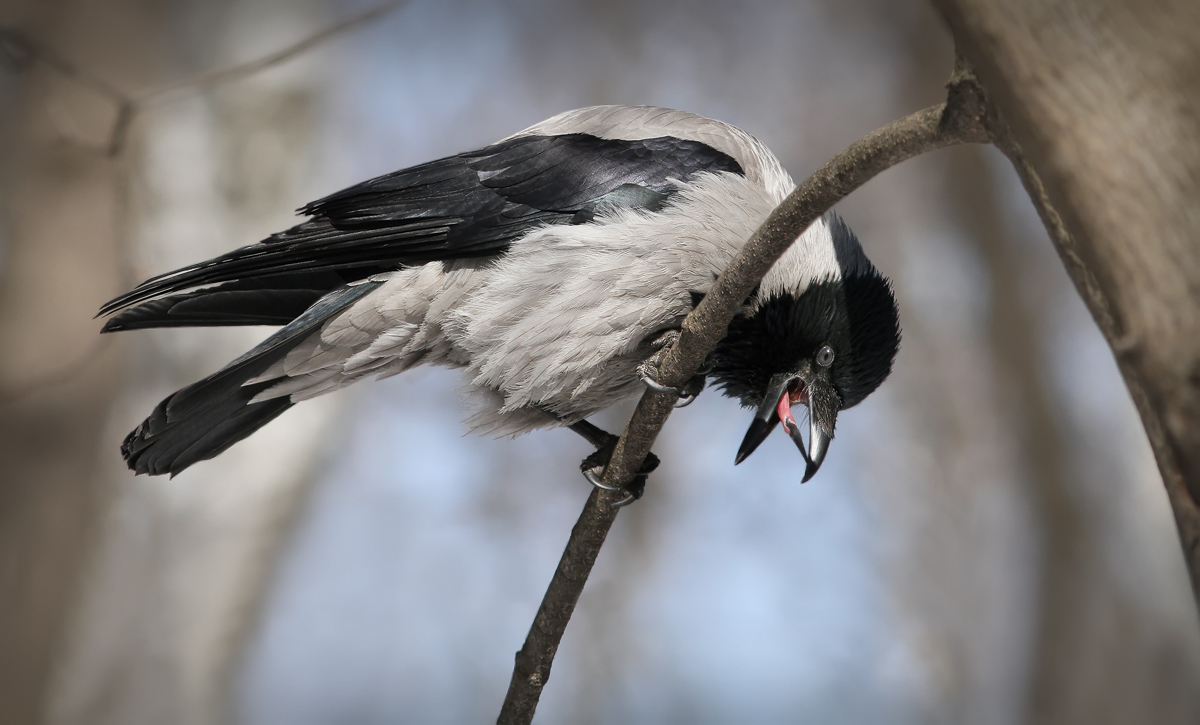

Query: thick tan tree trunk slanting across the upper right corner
[[935, 0, 1200, 597]]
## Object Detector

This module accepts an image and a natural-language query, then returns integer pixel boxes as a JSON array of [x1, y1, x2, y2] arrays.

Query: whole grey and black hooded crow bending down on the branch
[[98, 106, 900, 499]]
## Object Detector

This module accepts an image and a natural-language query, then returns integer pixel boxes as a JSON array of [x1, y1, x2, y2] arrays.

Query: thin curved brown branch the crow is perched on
[[497, 62, 991, 725]]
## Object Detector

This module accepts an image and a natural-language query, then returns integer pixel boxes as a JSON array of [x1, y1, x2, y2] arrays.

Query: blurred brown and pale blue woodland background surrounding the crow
[[0, 0, 1200, 725]]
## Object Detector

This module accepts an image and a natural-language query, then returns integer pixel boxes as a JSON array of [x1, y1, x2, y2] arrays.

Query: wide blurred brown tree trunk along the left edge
[[0, 0, 160, 725]]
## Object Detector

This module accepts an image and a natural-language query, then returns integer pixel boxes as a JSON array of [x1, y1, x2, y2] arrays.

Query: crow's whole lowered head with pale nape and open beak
[[712, 212, 900, 481]]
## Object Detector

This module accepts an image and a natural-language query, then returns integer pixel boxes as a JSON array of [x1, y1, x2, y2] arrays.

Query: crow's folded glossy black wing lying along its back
[[101, 133, 743, 331]]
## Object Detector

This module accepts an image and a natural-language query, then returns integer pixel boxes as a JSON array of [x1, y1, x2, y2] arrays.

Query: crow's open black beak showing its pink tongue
[[733, 373, 836, 483]]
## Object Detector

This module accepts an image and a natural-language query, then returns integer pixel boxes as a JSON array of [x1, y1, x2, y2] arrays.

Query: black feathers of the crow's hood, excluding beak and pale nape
[[712, 269, 900, 409]]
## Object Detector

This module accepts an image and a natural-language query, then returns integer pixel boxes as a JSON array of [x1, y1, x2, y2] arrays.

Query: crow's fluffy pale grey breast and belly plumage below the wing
[[252, 173, 796, 435]]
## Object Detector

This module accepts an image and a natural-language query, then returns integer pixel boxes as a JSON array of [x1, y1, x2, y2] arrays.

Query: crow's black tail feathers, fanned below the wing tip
[[121, 282, 379, 475]]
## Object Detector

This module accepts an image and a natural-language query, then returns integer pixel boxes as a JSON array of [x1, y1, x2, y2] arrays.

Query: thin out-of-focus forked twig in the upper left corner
[[0, 0, 408, 157]]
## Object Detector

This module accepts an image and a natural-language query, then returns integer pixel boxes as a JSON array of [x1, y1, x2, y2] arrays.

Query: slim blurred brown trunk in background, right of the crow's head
[[947, 144, 1099, 725]]
